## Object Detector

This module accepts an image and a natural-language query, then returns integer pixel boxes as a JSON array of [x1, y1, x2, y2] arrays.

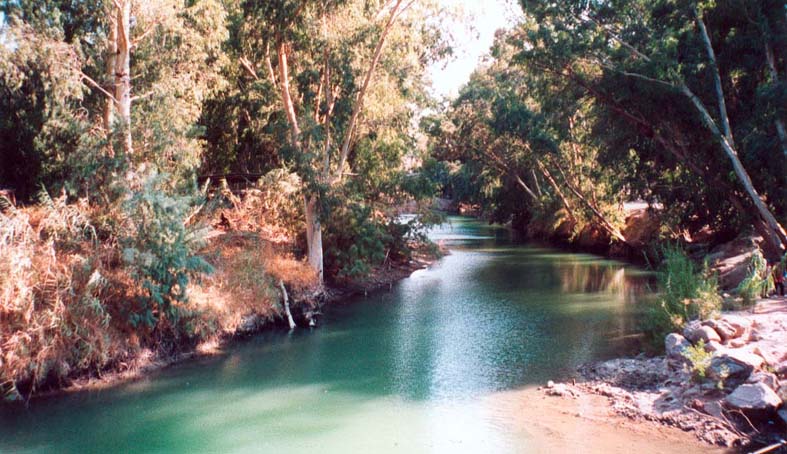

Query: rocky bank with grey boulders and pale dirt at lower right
[[541, 298, 787, 447]]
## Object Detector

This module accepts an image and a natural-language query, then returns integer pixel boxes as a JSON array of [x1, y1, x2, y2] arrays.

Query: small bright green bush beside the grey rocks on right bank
[[643, 246, 721, 345]]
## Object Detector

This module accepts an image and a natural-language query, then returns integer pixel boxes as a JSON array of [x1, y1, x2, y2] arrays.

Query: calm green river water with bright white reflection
[[0, 218, 651, 453]]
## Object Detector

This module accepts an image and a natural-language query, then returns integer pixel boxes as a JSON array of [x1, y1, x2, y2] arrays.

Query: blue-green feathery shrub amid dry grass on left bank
[[121, 174, 212, 328]]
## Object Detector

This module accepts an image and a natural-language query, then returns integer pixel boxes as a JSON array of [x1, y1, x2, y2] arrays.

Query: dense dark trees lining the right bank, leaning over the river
[[425, 0, 787, 260]]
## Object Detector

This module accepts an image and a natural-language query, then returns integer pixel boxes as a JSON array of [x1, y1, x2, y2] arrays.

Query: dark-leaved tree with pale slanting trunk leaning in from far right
[[518, 0, 787, 255]]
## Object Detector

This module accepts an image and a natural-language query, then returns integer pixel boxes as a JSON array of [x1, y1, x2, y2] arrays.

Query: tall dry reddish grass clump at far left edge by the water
[[0, 198, 129, 397]]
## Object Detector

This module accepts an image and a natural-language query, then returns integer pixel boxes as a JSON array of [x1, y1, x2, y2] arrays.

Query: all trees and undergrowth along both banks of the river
[[0, 0, 787, 396]]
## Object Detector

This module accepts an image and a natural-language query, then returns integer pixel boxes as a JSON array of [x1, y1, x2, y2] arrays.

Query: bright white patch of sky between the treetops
[[429, 0, 522, 98]]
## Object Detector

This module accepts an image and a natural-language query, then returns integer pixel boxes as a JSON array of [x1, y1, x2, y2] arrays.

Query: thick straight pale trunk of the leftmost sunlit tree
[[115, 0, 134, 159]]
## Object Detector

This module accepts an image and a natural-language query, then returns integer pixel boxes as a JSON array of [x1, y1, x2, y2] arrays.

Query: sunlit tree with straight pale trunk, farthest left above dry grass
[[2, 0, 227, 195]]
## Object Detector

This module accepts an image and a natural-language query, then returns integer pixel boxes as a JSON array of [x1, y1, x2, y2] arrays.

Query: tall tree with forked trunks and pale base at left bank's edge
[[238, 0, 450, 280]]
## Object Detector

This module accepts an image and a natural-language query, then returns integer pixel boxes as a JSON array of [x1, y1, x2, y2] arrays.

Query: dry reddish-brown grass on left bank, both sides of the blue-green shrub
[[0, 179, 317, 400]]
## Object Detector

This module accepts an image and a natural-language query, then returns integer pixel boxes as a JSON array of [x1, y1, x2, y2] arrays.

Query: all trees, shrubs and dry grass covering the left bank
[[0, 0, 450, 397]]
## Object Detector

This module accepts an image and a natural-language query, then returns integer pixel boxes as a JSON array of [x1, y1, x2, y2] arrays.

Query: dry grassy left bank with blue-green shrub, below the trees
[[0, 181, 432, 401]]
